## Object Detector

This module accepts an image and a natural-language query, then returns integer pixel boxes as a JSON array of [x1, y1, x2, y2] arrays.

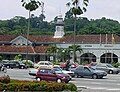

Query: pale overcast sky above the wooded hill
[[0, 0, 120, 22]]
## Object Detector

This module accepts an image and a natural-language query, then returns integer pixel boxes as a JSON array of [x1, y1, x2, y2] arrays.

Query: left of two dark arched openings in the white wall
[[80, 53, 96, 64]]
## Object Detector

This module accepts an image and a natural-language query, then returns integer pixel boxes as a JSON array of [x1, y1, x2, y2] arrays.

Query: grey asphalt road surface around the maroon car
[[0, 69, 120, 92]]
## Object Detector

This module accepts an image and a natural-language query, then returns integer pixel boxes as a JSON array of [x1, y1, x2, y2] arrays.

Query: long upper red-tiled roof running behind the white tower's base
[[0, 34, 120, 43]]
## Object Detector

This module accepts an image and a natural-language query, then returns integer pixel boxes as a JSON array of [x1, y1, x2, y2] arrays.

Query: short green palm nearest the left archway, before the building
[[68, 45, 83, 62]]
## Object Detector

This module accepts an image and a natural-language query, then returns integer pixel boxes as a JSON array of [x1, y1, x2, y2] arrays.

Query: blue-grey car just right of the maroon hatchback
[[74, 65, 107, 79]]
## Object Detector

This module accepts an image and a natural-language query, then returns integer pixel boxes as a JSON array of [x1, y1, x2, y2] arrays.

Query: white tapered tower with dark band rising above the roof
[[54, 15, 65, 38]]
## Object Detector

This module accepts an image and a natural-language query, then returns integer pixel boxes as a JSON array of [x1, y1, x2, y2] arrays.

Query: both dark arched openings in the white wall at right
[[80, 53, 118, 63]]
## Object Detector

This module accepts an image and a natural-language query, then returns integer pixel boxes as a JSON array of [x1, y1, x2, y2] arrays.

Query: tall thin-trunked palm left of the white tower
[[21, 0, 41, 60]]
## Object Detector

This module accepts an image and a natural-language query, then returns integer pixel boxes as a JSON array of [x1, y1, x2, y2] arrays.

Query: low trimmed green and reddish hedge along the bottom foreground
[[0, 80, 77, 92]]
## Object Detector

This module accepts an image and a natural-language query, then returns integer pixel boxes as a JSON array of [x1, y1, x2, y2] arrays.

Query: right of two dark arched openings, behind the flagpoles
[[100, 53, 118, 63]]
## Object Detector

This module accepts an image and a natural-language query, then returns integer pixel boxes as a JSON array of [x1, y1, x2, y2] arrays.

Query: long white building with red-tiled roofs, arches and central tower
[[0, 16, 120, 63]]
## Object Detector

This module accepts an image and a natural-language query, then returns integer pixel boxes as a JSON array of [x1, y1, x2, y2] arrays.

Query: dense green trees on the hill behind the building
[[0, 15, 120, 35]]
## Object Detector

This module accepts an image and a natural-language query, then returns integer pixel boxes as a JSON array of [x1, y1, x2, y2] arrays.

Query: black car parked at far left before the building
[[4, 60, 27, 69]]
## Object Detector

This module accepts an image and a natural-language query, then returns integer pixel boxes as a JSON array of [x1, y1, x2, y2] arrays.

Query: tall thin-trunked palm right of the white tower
[[66, 0, 89, 61]]
